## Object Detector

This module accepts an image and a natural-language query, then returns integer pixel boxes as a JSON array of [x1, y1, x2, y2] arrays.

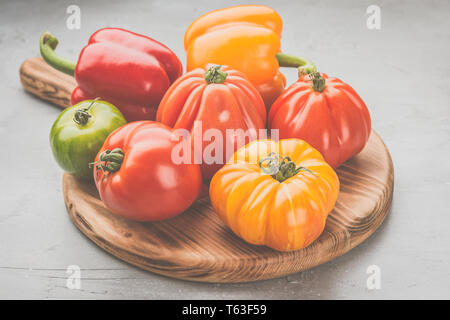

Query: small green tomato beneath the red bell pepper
[[50, 100, 126, 179]]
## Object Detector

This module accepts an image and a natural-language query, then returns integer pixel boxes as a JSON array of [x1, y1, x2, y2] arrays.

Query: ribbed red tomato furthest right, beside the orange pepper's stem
[[269, 72, 371, 168]]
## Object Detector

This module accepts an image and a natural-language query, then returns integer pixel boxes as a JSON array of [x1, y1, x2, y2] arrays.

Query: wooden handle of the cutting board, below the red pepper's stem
[[20, 57, 77, 108]]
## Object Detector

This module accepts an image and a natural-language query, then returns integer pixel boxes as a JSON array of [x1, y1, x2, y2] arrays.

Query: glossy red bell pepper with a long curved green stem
[[40, 28, 183, 121]]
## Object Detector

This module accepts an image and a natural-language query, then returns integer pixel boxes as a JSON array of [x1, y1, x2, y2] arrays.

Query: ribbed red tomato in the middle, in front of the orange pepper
[[156, 65, 266, 179]]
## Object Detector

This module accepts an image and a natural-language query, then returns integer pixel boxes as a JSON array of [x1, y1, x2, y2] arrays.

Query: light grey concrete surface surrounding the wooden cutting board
[[0, 0, 450, 299]]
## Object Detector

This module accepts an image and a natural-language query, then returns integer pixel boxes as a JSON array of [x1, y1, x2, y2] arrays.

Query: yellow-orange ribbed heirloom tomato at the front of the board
[[209, 139, 339, 251]]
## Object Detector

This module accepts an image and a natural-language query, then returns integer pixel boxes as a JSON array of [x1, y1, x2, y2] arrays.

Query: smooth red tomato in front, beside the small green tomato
[[94, 121, 202, 221]]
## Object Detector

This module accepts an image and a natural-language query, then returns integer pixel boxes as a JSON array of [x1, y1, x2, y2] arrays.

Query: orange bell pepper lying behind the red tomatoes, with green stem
[[184, 5, 315, 108]]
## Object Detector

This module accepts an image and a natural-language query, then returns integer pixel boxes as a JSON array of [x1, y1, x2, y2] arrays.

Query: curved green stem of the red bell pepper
[[39, 32, 76, 76]]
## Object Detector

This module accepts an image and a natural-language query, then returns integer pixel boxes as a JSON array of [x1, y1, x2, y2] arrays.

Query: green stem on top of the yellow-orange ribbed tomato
[[259, 152, 313, 182]]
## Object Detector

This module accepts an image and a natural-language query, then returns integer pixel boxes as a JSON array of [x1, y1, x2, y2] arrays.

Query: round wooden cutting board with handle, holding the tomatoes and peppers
[[21, 58, 394, 282]]
